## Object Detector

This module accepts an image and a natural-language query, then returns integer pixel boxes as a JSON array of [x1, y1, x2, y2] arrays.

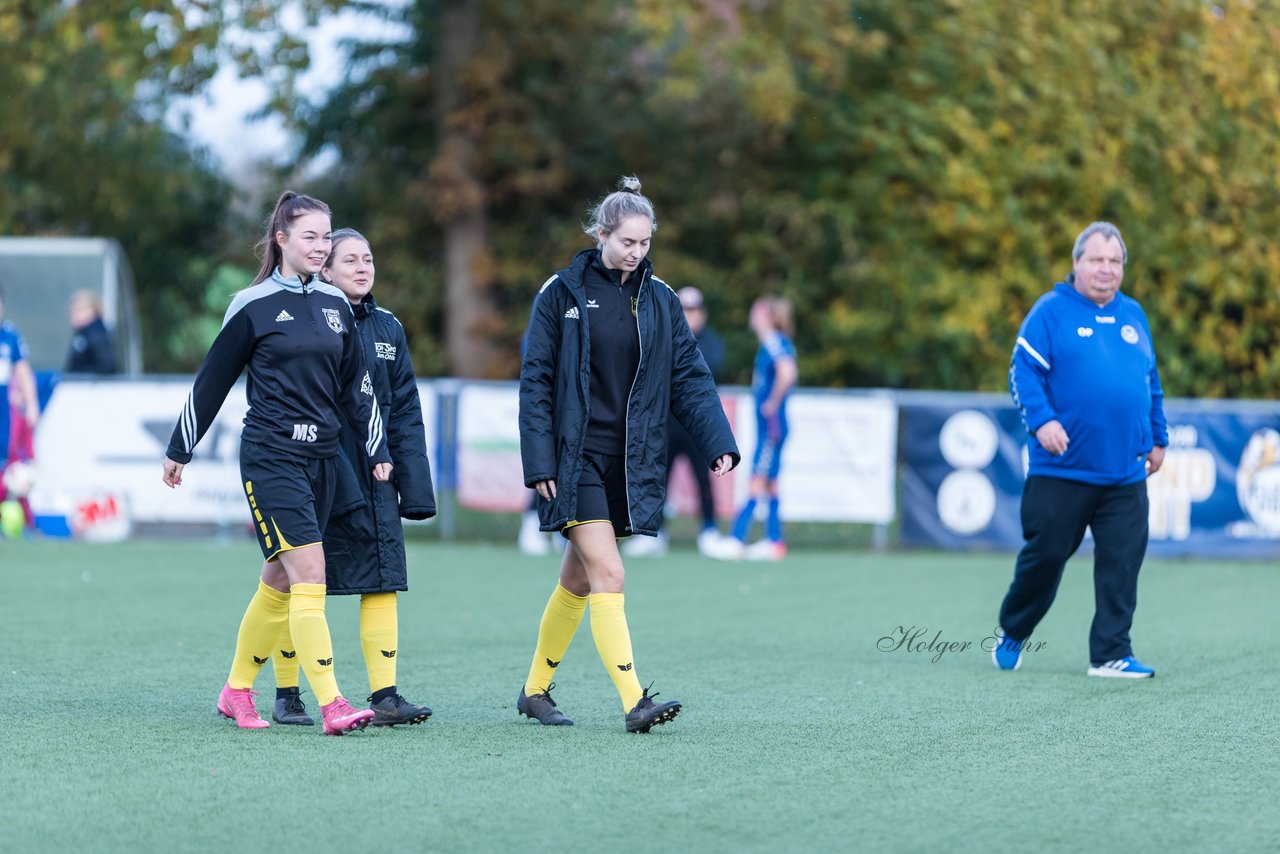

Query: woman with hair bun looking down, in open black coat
[[516, 178, 740, 732]]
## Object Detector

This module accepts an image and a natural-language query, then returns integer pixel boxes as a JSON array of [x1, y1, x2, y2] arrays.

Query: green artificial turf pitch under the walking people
[[0, 540, 1280, 853]]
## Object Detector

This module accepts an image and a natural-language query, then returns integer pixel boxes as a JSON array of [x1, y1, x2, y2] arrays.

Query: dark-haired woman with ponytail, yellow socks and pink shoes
[[164, 192, 392, 735]]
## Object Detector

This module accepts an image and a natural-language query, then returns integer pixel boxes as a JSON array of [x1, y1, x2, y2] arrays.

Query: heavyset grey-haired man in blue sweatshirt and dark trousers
[[992, 223, 1169, 679]]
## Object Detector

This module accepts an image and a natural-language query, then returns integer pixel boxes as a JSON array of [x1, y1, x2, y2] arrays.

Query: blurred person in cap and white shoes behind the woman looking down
[[623, 287, 724, 557]]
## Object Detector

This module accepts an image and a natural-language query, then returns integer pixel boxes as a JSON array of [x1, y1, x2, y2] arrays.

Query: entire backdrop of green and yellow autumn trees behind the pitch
[[12, 0, 1280, 397]]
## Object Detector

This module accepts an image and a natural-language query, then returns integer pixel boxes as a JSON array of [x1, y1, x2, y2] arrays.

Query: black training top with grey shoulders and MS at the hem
[[168, 270, 390, 463]]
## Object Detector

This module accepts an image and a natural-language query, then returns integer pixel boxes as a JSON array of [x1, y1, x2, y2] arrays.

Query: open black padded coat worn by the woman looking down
[[520, 250, 741, 535]]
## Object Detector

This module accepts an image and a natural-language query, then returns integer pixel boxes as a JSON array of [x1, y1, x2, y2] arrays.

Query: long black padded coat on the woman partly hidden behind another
[[324, 296, 435, 593]]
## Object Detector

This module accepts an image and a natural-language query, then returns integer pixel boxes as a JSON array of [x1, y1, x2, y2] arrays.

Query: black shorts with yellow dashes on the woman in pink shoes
[[241, 440, 338, 561]]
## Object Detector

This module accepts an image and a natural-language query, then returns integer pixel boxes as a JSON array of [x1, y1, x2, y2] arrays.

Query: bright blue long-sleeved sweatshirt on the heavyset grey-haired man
[[1009, 275, 1169, 485]]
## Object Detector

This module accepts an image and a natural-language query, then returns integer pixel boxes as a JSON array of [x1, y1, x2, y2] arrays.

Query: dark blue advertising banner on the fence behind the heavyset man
[[899, 396, 1280, 557]]
